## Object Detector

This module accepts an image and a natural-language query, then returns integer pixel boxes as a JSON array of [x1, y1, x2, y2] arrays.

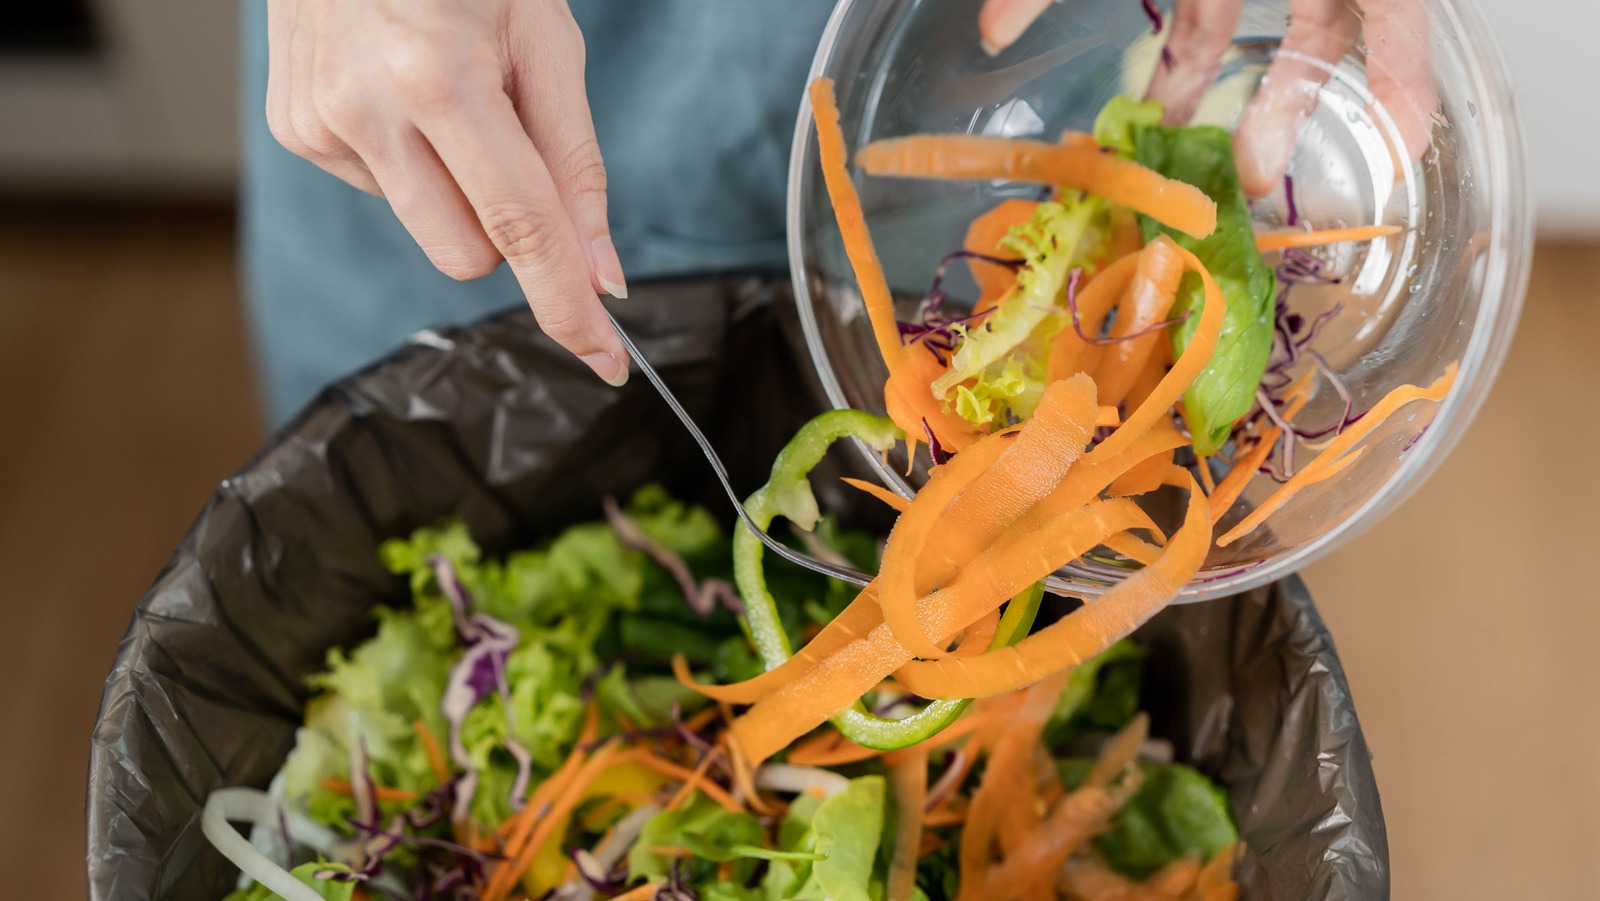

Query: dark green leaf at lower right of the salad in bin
[[1059, 759, 1238, 879]]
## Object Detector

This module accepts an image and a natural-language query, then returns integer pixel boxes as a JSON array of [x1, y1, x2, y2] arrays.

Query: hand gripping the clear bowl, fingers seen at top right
[[978, 0, 1438, 197]]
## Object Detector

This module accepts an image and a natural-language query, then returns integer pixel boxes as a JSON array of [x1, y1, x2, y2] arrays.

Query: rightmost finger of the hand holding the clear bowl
[[1360, 0, 1438, 163]]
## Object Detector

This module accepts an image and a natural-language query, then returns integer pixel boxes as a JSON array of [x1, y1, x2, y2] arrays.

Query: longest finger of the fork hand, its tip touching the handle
[[418, 72, 627, 386]]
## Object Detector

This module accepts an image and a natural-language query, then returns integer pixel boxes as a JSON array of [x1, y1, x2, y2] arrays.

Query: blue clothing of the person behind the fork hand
[[242, 0, 832, 422]]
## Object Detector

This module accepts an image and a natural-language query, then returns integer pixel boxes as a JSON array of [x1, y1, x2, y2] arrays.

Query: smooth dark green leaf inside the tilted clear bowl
[[1133, 125, 1277, 456]]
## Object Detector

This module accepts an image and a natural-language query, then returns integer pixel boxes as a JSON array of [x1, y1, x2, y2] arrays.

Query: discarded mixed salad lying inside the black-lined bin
[[206, 487, 1240, 901]]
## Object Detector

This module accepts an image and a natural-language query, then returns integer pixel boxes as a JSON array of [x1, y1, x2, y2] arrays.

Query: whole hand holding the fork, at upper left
[[267, 0, 627, 384]]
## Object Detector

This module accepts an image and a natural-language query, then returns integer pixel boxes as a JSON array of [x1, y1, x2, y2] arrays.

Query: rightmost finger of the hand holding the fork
[[507, 3, 627, 298]]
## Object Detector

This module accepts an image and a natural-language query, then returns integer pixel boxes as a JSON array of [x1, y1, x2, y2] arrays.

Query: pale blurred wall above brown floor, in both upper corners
[[0, 0, 1600, 235]]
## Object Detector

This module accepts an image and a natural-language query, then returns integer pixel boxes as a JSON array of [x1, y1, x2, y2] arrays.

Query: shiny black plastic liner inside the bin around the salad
[[88, 278, 1389, 901]]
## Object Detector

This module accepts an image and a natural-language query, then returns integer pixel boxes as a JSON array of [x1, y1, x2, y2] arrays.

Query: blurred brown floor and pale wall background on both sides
[[0, 0, 1600, 899]]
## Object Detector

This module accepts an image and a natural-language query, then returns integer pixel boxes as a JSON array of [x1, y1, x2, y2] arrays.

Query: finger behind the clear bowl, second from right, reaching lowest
[[1234, 0, 1362, 197]]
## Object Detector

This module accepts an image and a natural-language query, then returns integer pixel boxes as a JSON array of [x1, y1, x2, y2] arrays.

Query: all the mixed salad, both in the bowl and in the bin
[[203, 8, 1456, 901]]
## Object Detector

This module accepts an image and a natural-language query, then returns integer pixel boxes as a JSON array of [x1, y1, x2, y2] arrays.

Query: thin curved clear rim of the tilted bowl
[[786, 0, 1534, 603]]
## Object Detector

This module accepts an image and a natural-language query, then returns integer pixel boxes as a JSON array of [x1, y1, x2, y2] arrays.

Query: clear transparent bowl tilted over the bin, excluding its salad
[[789, 0, 1533, 600]]
